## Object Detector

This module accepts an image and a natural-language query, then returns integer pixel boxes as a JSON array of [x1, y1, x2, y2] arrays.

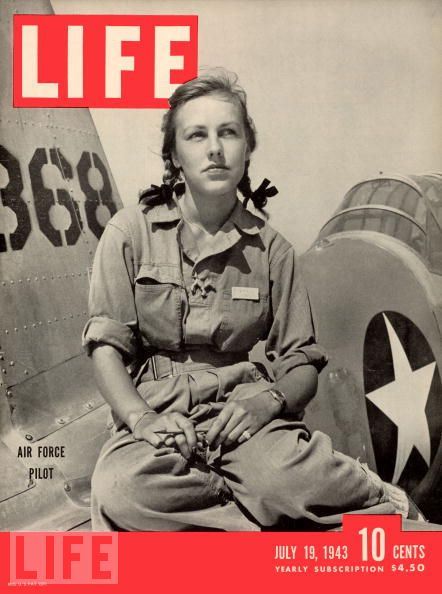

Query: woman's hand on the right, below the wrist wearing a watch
[[207, 391, 281, 449]]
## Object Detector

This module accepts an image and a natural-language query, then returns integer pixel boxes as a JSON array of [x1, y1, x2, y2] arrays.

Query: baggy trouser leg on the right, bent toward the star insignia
[[219, 419, 394, 526]]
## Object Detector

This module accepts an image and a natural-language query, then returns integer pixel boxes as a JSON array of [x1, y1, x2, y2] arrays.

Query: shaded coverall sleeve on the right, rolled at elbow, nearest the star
[[266, 247, 327, 381]]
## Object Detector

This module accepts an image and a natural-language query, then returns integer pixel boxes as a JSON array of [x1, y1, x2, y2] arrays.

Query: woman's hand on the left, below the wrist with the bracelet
[[133, 412, 197, 458]]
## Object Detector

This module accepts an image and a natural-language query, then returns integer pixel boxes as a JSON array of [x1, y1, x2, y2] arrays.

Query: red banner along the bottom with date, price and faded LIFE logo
[[0, 515, 442, 594]]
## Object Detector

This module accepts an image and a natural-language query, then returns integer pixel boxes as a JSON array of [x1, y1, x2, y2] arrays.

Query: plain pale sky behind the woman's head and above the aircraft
[[52, 0, 442, 252]]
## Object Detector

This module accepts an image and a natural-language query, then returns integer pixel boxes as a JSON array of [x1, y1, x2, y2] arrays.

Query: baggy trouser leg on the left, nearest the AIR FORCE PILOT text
[[92, 432, 257, 531]]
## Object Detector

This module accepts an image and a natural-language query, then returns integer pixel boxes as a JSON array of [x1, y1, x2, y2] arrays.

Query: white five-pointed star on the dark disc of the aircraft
[[366, 314, 436, 483]]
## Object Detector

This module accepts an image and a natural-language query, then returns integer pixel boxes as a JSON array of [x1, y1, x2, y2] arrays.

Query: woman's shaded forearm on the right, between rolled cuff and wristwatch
[[274, 365, 318, 414]]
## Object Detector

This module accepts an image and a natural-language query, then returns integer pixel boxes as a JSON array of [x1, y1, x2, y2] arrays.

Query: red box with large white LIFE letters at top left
[[13, 14, 198, 108]]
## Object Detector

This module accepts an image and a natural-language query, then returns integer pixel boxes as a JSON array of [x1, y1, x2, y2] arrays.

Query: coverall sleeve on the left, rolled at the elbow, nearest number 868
[[83, 221, 138, 363]]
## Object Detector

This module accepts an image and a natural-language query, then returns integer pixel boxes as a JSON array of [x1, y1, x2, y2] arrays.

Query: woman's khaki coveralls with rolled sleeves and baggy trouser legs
[[84, 201, 394, 531]]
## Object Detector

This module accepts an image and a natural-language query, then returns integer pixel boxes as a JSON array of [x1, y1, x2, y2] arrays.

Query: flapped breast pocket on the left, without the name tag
[[135, 264, 183, 350]]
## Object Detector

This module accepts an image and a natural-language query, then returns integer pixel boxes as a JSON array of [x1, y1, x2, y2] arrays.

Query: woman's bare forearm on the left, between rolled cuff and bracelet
[[92, 344, 155, 429]]
